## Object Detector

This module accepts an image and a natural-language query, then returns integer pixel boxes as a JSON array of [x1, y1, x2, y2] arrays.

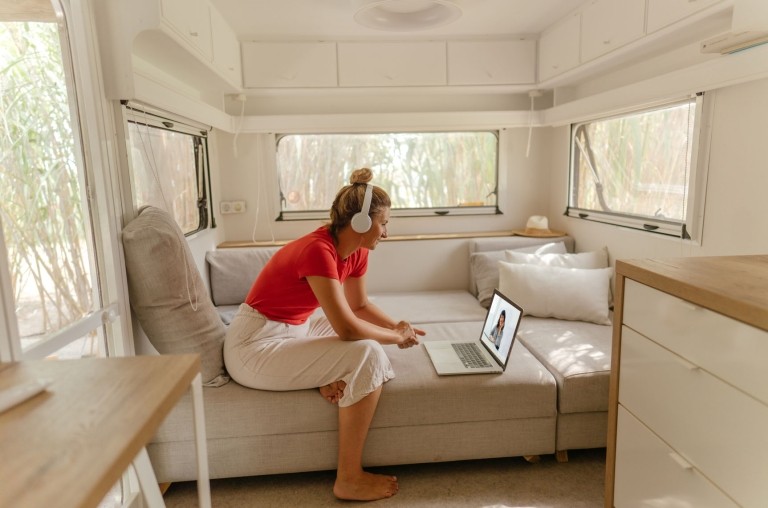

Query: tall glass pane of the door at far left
[[0, 7, 107, 359]]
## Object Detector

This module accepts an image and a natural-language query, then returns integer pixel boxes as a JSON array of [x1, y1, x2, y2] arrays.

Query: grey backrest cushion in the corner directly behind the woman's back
[[205, 247, 280, 306]]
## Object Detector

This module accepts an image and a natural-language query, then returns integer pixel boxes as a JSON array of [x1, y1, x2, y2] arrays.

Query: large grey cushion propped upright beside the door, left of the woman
[[122, 206, 229, 386]]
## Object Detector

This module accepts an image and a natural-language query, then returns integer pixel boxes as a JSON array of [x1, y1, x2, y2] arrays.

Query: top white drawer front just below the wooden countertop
[[623, 279, 768, 404]]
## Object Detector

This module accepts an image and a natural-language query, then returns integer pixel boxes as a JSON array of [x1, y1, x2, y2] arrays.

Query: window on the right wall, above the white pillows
[[567, 96, 703, 238]]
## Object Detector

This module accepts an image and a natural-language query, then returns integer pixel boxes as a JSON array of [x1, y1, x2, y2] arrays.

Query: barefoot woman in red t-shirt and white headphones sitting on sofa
[[224, 168, 424, 501]]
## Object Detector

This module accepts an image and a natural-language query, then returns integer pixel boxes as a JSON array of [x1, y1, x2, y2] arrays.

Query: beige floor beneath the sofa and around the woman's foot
[[165, 449, 605, 508]]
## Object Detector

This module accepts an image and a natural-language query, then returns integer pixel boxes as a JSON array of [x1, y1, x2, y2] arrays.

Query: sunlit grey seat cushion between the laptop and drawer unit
[[518, 316, 613, 413]]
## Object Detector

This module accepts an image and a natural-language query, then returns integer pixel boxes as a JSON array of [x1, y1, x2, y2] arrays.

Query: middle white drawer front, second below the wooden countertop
[[619, 326, 768, 506]]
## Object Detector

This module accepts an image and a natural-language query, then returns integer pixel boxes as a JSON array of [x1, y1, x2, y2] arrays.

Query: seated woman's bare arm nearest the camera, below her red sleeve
[[307, 276, 418, 347]]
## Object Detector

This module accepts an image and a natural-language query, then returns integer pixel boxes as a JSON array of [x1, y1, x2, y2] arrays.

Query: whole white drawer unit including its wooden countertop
[[605, 256, 768, 507]]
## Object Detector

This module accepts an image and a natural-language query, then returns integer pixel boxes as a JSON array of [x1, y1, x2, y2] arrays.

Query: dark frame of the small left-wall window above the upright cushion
[[120, 101, 216, 237]]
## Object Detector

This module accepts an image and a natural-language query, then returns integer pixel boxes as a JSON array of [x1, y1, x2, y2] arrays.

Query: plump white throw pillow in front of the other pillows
[[499, 261, 613, 325]]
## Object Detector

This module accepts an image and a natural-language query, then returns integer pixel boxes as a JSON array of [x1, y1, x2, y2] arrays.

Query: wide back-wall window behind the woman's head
[[277, 132, 498, 219]]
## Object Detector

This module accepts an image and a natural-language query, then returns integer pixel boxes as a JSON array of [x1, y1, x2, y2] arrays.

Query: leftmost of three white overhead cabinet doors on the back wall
[[242, 42, 337, 88]]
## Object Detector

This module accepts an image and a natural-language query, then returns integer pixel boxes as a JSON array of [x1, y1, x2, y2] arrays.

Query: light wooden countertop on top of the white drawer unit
[[616, 255, 768, 330]]
